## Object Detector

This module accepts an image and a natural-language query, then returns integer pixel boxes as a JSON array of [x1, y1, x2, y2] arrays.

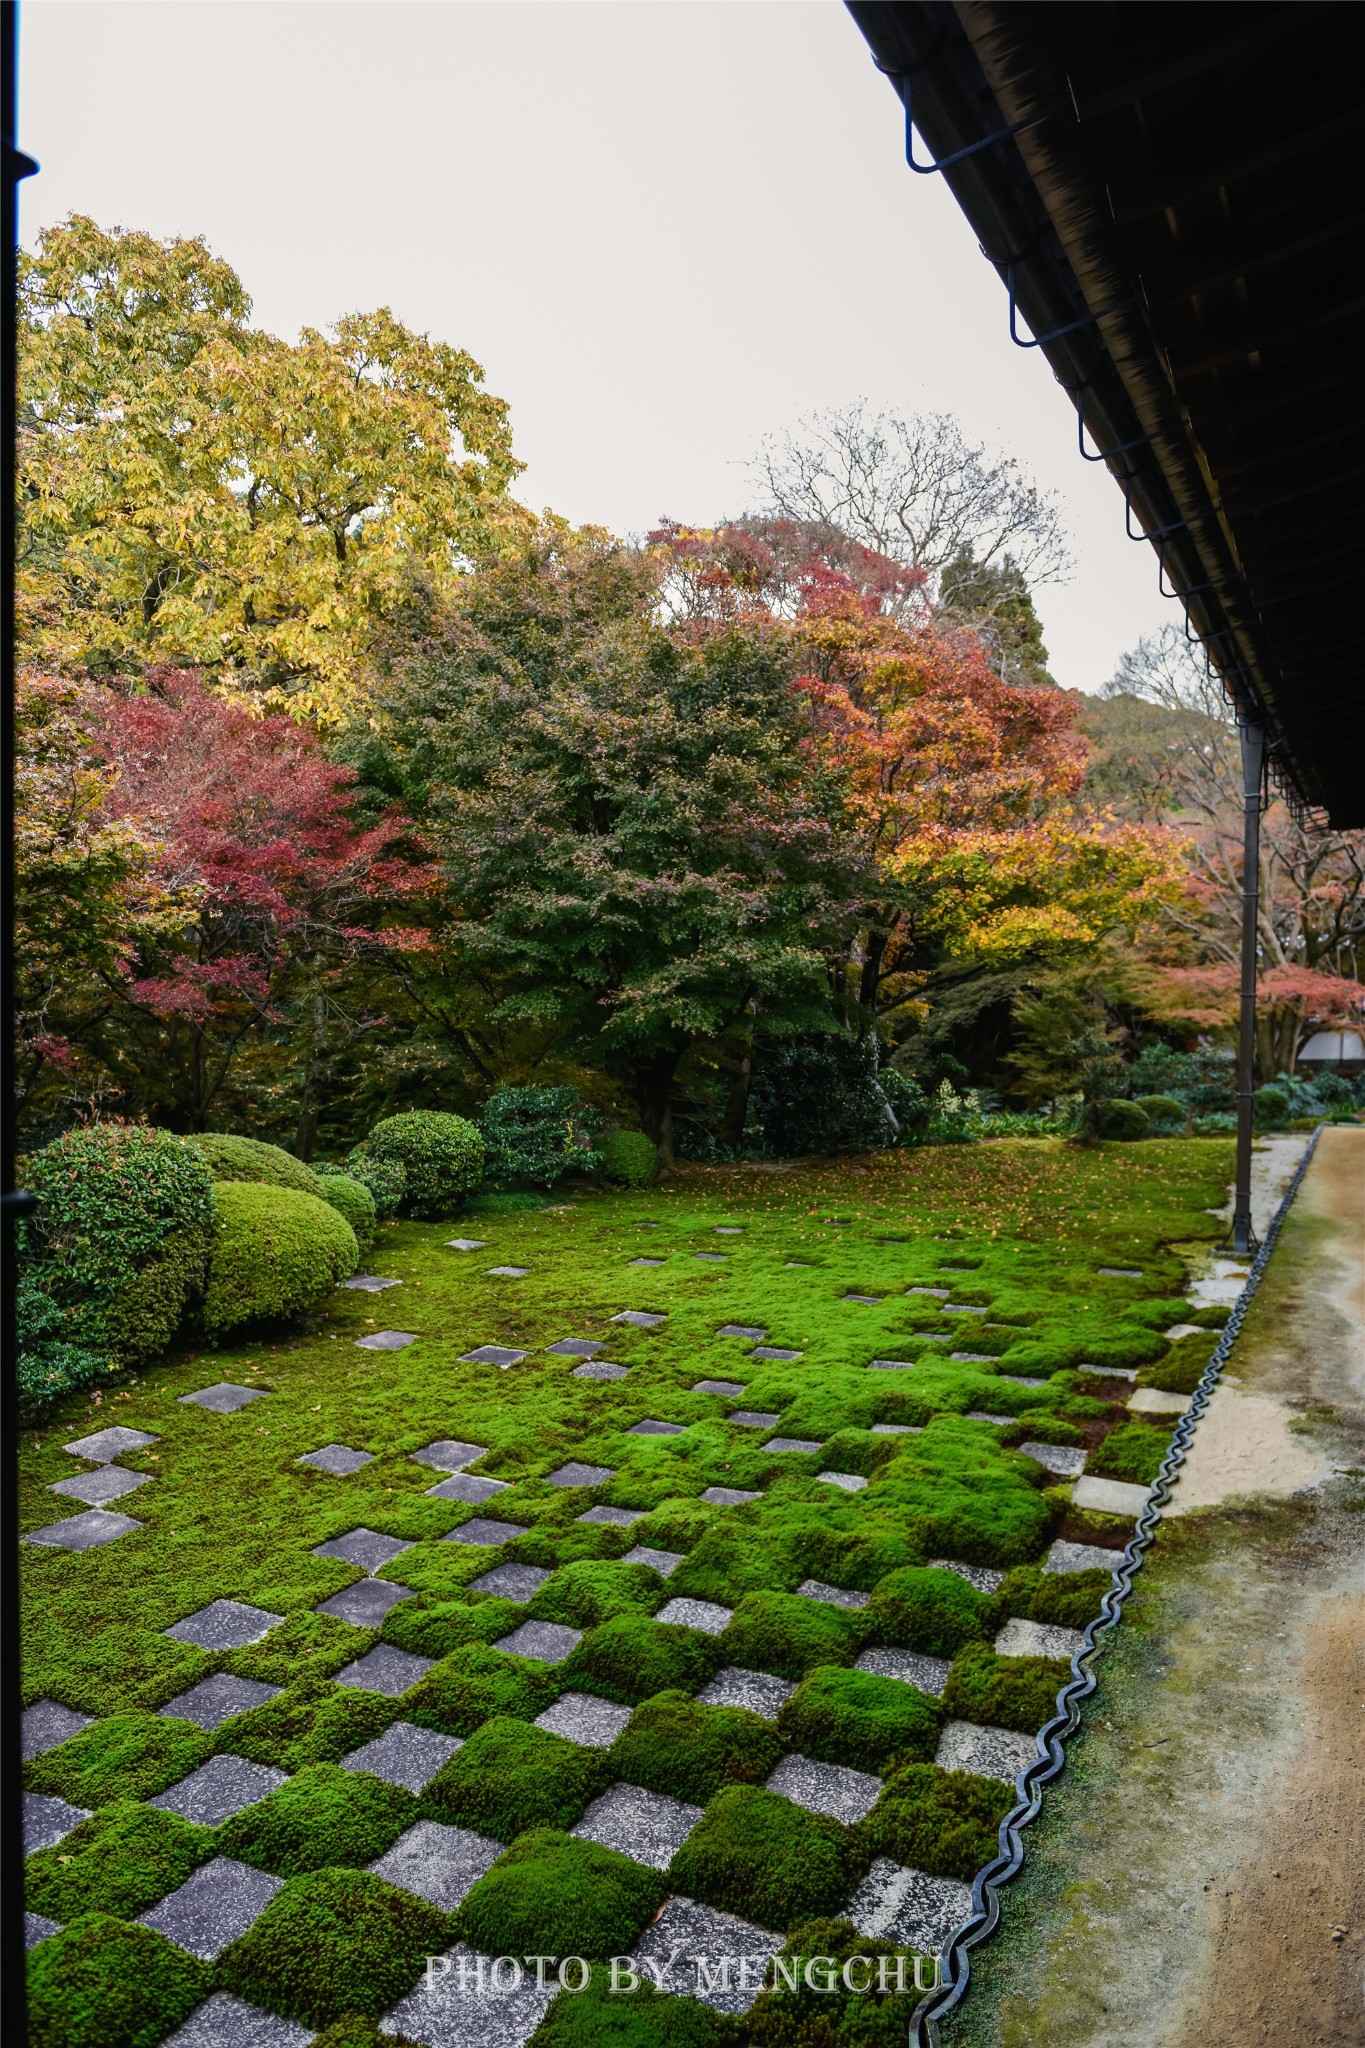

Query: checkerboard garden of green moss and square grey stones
[[23, 1139, 1230, 2048]]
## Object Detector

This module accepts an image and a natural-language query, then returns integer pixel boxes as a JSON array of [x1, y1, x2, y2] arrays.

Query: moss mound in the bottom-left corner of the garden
[[27, 1913, 213, 2048]]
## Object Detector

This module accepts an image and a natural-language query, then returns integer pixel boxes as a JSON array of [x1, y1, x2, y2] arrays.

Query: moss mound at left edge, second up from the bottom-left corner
[[25, 1800, 213, 1925]]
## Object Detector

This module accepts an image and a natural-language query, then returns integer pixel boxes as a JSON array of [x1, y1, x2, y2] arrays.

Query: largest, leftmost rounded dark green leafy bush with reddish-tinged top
[[16, 1124, 215, 1403]]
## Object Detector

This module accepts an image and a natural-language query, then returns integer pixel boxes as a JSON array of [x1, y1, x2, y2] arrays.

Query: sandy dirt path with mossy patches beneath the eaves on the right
[[941, 1128, 1365, 2048]]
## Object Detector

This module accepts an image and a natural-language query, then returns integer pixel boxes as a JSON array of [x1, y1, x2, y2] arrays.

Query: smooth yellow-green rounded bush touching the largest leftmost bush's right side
[[203, 1180, 360, 1337]]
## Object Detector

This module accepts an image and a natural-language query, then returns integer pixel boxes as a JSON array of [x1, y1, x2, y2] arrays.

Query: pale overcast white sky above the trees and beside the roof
[[20, 0, 1173, 690]]
